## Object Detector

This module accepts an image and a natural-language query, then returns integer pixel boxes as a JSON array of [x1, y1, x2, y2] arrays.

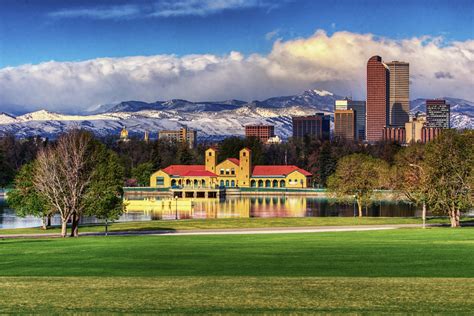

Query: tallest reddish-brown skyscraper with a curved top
[[365, 56, 390, 142]]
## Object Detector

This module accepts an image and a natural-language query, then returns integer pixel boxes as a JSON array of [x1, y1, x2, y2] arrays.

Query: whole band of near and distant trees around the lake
[[0, 130, 474, 236]]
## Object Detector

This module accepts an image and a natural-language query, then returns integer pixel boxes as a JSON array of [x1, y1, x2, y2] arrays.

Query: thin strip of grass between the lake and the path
[[0, 217, 474, 235]]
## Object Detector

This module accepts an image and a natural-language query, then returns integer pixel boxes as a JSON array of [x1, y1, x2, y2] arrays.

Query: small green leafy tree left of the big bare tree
[[8, 163, 53, 229]]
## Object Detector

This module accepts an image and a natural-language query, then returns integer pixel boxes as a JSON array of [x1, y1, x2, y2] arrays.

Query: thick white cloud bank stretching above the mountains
[[0, 30, 474, 111]]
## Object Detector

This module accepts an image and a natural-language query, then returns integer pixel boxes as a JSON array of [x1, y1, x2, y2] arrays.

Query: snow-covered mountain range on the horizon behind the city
[[0, 89, 474, 140]]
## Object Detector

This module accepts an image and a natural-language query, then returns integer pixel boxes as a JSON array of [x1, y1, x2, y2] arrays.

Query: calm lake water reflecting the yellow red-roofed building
[[0, 196, 421, 228]]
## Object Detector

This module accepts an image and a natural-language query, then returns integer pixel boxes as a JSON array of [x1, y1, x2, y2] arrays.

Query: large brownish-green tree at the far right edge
[[426, 130, 474, 227]]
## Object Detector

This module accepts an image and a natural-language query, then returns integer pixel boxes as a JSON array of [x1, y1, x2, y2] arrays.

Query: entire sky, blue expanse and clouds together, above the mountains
[[0, 0, 474, 111]]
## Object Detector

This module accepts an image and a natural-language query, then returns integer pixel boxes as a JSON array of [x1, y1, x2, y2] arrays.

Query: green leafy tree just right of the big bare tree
[[84, 145, 124, 234]]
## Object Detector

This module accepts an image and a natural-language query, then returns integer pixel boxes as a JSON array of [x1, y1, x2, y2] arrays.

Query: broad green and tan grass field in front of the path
[[0, 228, 474, 314]]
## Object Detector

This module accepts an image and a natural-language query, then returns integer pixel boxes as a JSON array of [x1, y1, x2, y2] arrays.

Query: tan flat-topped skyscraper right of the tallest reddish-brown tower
[[387, 61, 410, 126]]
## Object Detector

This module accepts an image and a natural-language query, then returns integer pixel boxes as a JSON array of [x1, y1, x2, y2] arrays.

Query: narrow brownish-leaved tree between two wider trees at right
[[392, 143, 428, 228]]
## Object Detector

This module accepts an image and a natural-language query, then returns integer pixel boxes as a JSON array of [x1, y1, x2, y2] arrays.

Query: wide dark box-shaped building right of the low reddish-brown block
[[292, 113, 331, 139]]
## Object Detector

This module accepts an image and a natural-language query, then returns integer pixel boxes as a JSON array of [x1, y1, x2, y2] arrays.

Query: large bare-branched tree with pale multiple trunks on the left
[[33, 130, 94, 237]]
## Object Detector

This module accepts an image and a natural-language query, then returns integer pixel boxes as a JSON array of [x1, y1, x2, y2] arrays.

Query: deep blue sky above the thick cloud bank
[[0, 0, 474, 68]]
